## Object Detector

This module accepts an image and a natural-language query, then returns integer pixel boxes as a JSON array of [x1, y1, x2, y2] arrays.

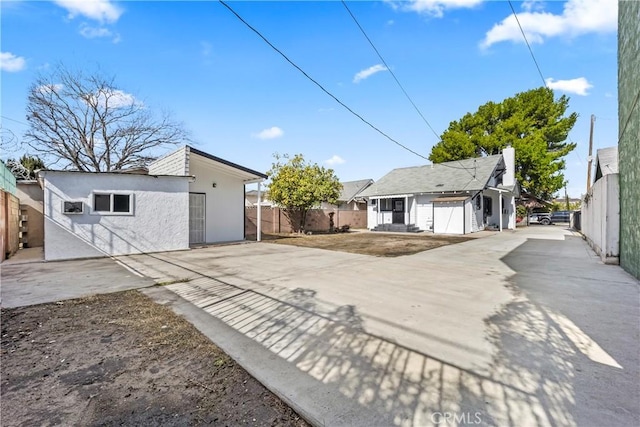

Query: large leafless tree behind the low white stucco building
[[25, 65, 188, 172]]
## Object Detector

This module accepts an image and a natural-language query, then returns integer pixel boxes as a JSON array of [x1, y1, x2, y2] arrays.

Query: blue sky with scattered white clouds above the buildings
[[0, 0, 618, 196]]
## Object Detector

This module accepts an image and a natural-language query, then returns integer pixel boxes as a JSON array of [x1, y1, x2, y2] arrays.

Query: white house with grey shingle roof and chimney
[[360, 147, 519, 234]]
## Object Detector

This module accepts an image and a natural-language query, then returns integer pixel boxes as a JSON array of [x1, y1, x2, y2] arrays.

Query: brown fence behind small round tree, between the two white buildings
[[244, 206, 367, 238]]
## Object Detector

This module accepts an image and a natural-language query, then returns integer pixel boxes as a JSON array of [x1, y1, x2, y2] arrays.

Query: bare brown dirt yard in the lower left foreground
[[0, 291, 307, 426]]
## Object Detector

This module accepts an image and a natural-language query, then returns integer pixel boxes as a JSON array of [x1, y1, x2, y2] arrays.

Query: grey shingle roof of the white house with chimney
[[360, 154, 504, 197]]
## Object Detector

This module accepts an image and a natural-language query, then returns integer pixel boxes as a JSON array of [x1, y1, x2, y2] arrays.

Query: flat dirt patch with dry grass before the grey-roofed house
[[264, 232, 472, 257]]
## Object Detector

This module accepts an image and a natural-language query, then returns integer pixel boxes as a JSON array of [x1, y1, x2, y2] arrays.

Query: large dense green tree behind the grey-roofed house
[[429, 88, 578, 199]]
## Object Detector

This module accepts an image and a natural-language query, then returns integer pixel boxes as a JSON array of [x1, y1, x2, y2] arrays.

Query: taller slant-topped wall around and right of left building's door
[[189, 154, 244, 243]]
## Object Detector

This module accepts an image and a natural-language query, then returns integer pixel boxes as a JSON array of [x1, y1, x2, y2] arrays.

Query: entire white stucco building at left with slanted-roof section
[[39, 146, 267, 261]]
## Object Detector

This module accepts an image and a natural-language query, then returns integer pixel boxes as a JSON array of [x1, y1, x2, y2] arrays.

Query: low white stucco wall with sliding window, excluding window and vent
[[43, 171, 189, 260]]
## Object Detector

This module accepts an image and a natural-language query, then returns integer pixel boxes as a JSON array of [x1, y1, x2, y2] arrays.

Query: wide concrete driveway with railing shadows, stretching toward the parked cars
[[112, 226, 640, 426]]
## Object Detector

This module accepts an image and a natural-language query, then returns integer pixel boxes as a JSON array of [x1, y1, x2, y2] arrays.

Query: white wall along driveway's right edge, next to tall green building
[[581, 174, 620, 264]]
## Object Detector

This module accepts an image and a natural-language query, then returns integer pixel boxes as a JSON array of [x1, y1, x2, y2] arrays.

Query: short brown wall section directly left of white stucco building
[[16, 181, 44, 248]]
